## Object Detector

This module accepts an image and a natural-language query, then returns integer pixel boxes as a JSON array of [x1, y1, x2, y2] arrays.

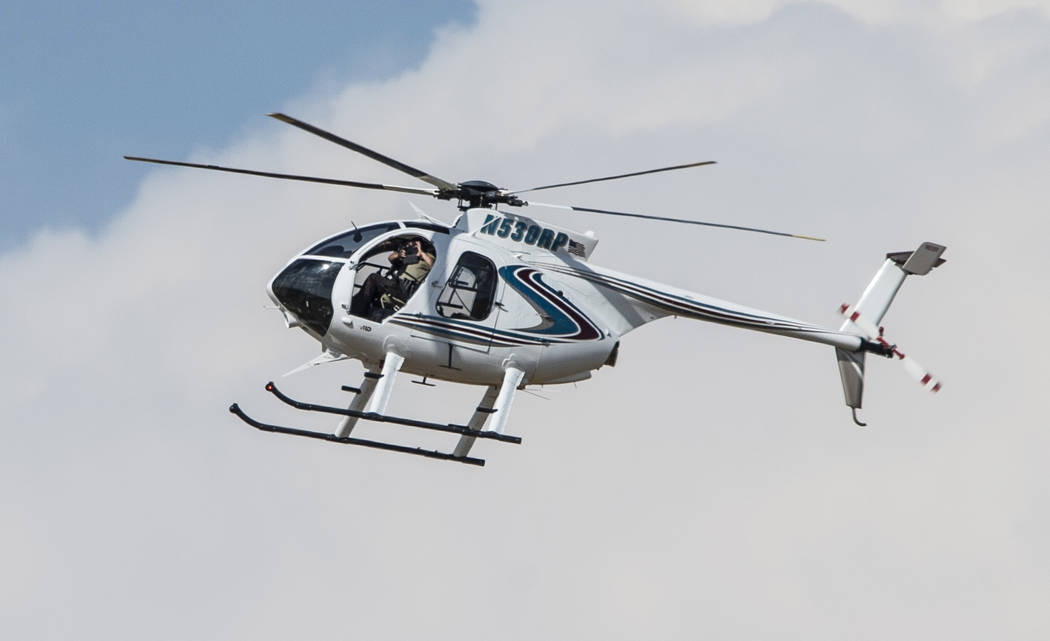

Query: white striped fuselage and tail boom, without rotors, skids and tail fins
[[269, 208, 861, 386]]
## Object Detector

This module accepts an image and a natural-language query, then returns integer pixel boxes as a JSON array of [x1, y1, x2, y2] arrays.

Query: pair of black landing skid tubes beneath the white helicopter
[[230, 381, 522, 466]]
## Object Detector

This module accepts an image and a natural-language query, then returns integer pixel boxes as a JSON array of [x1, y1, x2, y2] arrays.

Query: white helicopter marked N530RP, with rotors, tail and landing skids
[[124, 113, 945, 466]]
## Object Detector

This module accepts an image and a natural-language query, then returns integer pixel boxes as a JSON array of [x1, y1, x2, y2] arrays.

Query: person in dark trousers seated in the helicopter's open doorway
[[350, 239, 435, 321]]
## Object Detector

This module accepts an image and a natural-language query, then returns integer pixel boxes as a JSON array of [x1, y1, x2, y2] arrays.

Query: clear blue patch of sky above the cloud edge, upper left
[[0, 0, 475, 249]]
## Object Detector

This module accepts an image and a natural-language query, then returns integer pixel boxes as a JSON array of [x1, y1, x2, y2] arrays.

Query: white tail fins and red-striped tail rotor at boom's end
[[835, 243, 945, 427]]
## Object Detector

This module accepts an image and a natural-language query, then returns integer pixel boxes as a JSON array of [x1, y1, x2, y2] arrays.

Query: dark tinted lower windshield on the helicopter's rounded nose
[[270, 259, 341, 336]]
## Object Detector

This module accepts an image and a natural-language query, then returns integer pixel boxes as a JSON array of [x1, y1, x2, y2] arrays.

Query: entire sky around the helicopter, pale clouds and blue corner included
[[0, 0, 1050, 640]]
